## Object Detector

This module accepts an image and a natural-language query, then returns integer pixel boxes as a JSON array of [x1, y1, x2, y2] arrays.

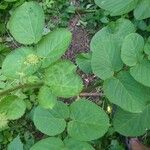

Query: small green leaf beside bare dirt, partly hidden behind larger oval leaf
[[76, 53, 92, 73]]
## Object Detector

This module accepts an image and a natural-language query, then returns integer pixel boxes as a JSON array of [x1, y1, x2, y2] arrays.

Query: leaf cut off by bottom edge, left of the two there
[[30, 137, 65, 150]]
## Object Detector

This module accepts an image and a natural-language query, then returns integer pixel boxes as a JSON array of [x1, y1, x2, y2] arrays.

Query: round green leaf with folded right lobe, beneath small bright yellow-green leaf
[[33, 102, 69, 136]]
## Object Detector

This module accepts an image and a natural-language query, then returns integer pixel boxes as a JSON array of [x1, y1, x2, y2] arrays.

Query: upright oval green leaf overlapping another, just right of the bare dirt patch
[[91, 35, 123, 80]]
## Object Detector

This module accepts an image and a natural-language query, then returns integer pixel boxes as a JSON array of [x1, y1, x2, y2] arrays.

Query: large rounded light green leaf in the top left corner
[[7, 2, 44, 44]]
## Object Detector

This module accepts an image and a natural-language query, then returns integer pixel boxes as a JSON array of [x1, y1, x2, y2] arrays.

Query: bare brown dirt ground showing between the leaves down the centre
[[63, 0, 101, 103]]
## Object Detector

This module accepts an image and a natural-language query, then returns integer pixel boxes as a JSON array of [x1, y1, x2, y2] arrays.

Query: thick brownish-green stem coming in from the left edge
[[0, 82, 43, 97]]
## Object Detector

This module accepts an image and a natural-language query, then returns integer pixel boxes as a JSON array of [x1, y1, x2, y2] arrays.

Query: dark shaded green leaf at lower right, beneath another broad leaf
[[113, 105, 150, 137]]
